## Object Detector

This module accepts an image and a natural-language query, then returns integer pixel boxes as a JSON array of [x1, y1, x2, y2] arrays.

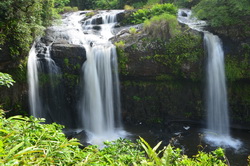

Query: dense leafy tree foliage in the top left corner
[[0, 0, 69, 57]]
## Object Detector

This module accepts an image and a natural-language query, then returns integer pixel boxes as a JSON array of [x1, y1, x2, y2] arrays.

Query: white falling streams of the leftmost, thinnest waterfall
[[28, 43, 63, 124]]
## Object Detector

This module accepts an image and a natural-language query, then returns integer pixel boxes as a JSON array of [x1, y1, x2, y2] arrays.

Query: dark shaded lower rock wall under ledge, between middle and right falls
[[121, 79, 205, 125]]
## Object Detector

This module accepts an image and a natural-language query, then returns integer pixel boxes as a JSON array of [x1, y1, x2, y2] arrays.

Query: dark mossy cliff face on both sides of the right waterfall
[[112, 14, 250, 128]]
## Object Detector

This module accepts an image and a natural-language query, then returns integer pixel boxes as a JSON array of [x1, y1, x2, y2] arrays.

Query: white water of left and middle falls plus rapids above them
[[28, 10, 125, 144]]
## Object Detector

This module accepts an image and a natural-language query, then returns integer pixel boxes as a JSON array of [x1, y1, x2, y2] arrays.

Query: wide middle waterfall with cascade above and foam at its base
[[79, 10, 122, 144]]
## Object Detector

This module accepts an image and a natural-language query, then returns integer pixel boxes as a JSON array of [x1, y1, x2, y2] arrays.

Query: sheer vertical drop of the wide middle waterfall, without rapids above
[[81, 45, 120, 134]]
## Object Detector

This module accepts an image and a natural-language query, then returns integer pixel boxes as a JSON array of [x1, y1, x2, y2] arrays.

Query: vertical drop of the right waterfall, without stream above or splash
[[204, 32, 229, 136]]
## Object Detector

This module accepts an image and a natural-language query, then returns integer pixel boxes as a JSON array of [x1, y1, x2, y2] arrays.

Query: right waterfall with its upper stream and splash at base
[[178, 9, 241, 149]]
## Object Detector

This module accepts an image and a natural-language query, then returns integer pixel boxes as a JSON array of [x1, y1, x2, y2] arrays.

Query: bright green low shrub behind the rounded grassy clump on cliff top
[[129, 3, 177, 24]]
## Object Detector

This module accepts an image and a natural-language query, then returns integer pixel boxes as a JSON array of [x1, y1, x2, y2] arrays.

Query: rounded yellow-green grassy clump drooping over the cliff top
[[144, 13, 181, 40]]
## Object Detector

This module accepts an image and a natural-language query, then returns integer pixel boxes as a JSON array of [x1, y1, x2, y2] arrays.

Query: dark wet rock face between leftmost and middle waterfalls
[[29, 29, 86, 128]]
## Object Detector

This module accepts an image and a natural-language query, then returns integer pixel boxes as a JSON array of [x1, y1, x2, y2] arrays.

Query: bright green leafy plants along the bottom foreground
[[0, 109, 232, 166]]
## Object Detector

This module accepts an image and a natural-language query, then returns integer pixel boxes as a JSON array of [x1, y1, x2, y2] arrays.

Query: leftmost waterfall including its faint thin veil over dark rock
[[28, 41, 70, 126]]
